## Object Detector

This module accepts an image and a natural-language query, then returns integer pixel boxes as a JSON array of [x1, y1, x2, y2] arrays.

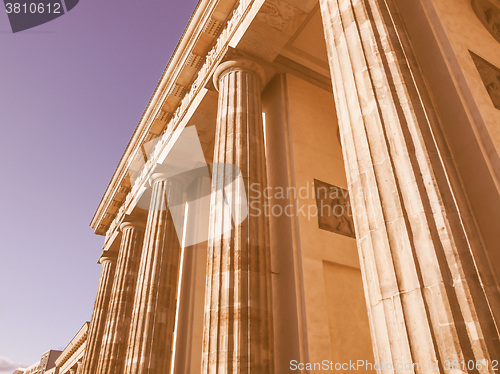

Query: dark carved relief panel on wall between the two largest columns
[[314, 179, 356, 238]]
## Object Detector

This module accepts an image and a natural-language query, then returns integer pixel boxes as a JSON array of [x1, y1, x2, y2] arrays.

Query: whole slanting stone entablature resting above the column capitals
[[91, 0, 328, 248]]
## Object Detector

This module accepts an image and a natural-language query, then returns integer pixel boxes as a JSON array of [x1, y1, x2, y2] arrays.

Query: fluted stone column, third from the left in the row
[[125, 173, 182, 374]]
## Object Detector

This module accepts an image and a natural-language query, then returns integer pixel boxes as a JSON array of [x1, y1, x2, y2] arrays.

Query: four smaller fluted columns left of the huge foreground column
[[83, 57, 272, 374]]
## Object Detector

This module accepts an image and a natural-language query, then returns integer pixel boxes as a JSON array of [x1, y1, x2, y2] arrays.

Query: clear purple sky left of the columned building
[[0, 0, 197, 374]]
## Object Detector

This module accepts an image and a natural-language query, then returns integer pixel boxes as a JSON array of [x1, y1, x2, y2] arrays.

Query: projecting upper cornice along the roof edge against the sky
[[90, 0, 240, 235]]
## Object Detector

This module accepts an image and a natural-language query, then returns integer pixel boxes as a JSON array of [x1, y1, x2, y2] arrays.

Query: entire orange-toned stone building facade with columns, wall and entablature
[[78, 0, 500, 374]]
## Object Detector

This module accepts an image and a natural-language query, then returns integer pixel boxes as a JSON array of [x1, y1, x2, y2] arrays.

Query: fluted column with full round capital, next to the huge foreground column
[[202, 60, 273, 374]]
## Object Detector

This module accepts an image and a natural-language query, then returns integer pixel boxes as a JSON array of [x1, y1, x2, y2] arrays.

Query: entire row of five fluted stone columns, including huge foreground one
[[83, 0, 499, 374]]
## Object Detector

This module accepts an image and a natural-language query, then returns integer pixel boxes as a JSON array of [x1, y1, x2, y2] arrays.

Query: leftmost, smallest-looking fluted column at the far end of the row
[[82, 251, 117, 374]]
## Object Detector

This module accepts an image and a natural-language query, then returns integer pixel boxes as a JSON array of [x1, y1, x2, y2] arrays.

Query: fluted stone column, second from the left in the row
[[97, 221, 145, 374]]
